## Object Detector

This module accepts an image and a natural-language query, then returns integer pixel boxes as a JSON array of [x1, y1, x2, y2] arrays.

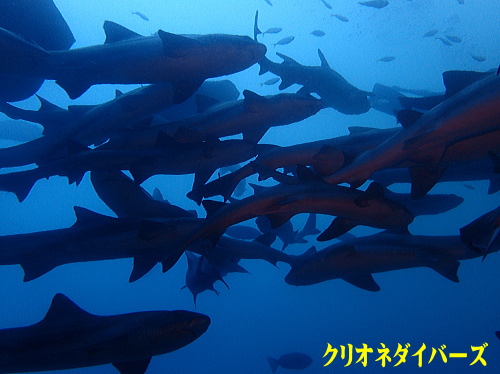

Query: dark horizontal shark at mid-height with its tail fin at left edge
[[0, 137, 269, 201]]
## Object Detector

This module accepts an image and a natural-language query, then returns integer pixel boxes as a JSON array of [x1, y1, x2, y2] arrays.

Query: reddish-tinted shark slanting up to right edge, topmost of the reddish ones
[[325, 69, 500, 197]]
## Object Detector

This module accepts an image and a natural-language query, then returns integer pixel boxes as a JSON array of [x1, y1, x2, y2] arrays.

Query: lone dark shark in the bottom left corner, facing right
[[0, 294, 210, 374]]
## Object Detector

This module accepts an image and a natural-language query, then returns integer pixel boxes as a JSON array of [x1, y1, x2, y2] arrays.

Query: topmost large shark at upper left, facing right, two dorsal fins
[[0, 21, 266, 99]]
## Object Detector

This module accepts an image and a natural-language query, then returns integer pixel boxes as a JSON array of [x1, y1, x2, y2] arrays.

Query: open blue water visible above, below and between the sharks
[[0, 0, 500, 374]]
